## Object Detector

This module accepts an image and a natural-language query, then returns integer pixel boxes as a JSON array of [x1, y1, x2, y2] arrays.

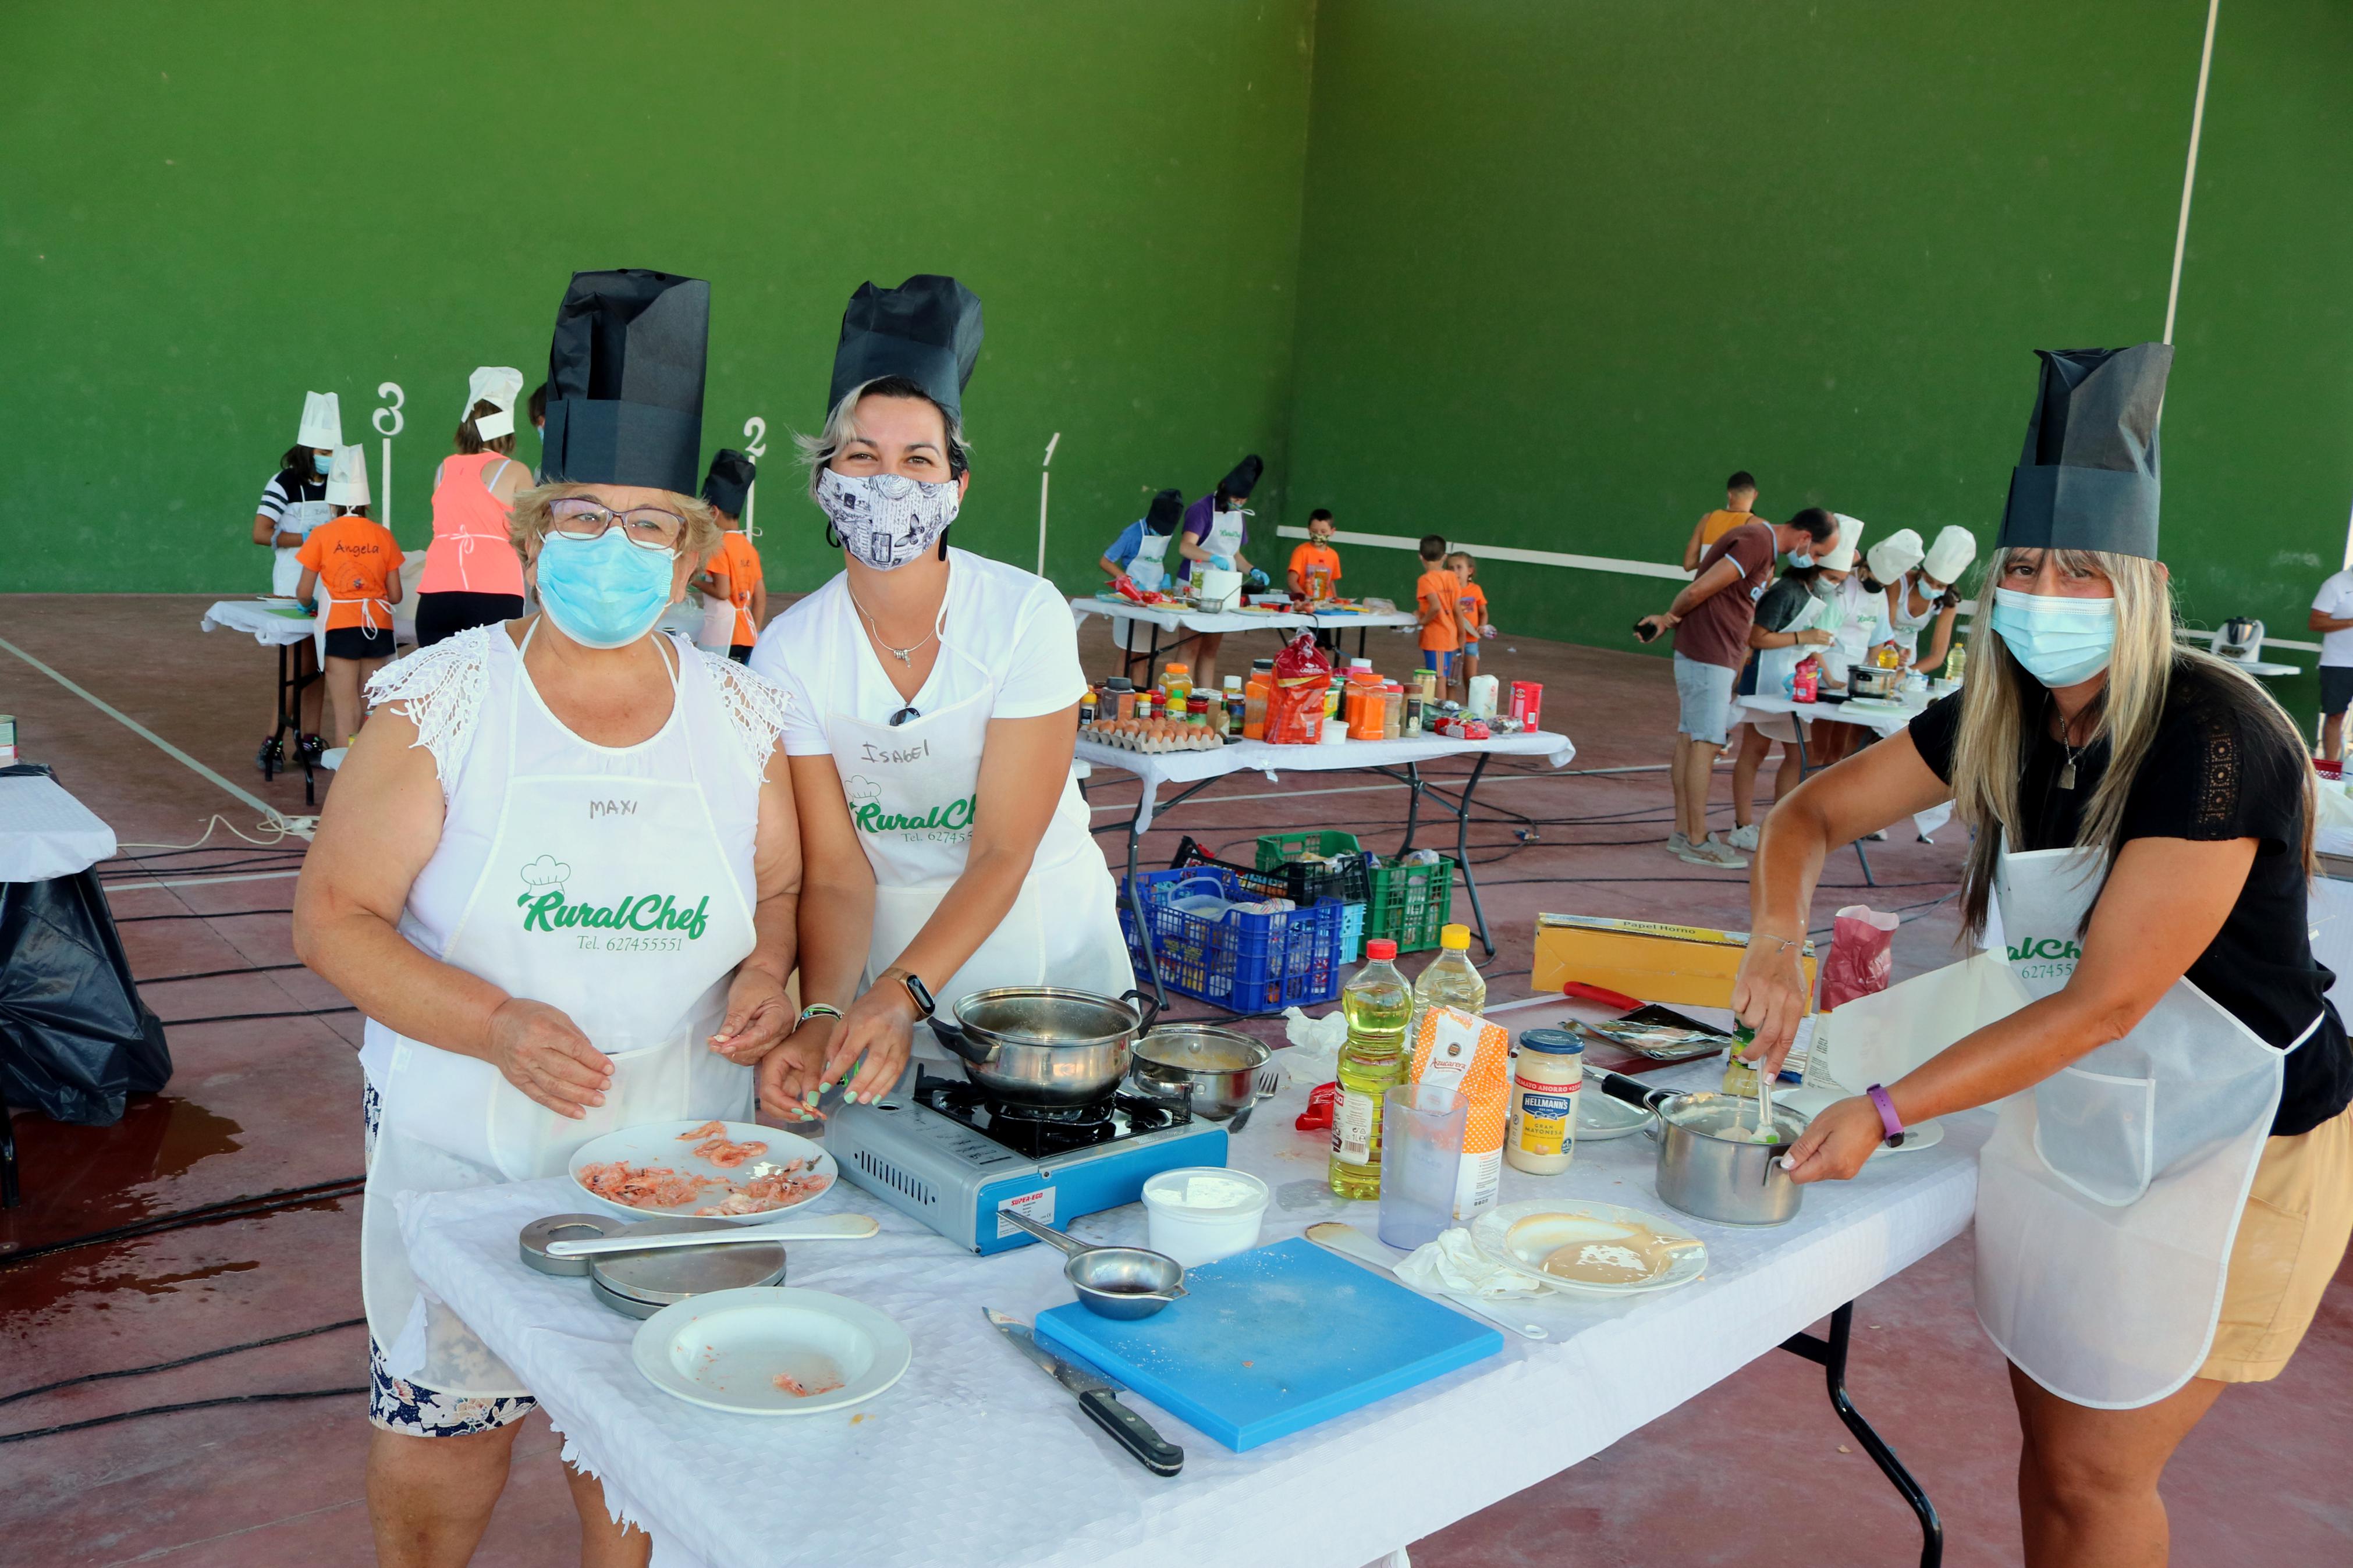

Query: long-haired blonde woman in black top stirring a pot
[[1732, 343, 2353, 1566]]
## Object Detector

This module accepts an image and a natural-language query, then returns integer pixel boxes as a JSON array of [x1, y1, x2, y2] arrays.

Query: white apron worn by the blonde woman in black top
[[1976, 849, 2320, 1410]]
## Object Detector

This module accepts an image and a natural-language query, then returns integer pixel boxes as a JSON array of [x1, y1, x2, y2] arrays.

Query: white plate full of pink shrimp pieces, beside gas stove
[[572, 1121, 840, 1225]]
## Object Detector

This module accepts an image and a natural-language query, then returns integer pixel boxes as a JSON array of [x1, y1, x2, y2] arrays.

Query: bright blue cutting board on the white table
[[1038, 1236, 1503, 1453]]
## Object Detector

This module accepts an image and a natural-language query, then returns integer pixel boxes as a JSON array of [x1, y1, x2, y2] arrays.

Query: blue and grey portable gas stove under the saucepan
[[826, 1072, 1226, 1253]]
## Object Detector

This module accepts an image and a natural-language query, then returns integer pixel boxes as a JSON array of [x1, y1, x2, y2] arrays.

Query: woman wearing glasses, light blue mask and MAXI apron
[[294, 271, 800, 1566]]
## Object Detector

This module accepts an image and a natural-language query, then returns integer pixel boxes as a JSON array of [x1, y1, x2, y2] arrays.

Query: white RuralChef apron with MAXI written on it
[[360, 623, 753, 1399]]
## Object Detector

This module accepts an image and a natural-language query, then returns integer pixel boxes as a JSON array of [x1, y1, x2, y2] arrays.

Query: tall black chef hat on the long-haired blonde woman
[[1995, 343, 2174, 560]]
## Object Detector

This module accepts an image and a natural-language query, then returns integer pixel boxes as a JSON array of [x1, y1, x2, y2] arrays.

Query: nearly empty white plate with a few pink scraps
[[631, 1286, 915, 1415]]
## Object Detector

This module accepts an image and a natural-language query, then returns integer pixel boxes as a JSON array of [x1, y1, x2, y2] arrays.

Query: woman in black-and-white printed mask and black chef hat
[[751, 275, 1134, 1117]]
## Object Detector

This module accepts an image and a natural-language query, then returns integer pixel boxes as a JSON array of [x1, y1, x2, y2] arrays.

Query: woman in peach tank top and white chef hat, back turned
[[417, 364, 532, 649]]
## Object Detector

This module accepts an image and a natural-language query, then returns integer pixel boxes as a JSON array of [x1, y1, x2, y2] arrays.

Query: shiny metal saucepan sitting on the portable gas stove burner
[[932, 985, 1160, 1105]]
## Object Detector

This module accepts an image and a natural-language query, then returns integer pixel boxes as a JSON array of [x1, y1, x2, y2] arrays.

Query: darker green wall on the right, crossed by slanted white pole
[[1292, 0, 2353, 701]]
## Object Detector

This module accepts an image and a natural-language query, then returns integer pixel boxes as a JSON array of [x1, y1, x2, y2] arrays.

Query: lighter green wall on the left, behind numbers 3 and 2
[[0, 0, 1313, 592]]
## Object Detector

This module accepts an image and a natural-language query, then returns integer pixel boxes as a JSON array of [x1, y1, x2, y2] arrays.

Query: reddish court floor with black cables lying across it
[[0, 595, 2353, 1568]]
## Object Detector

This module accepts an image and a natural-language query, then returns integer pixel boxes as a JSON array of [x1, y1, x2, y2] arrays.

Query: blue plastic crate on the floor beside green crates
[[1120, 865, 1346, 1013]]
